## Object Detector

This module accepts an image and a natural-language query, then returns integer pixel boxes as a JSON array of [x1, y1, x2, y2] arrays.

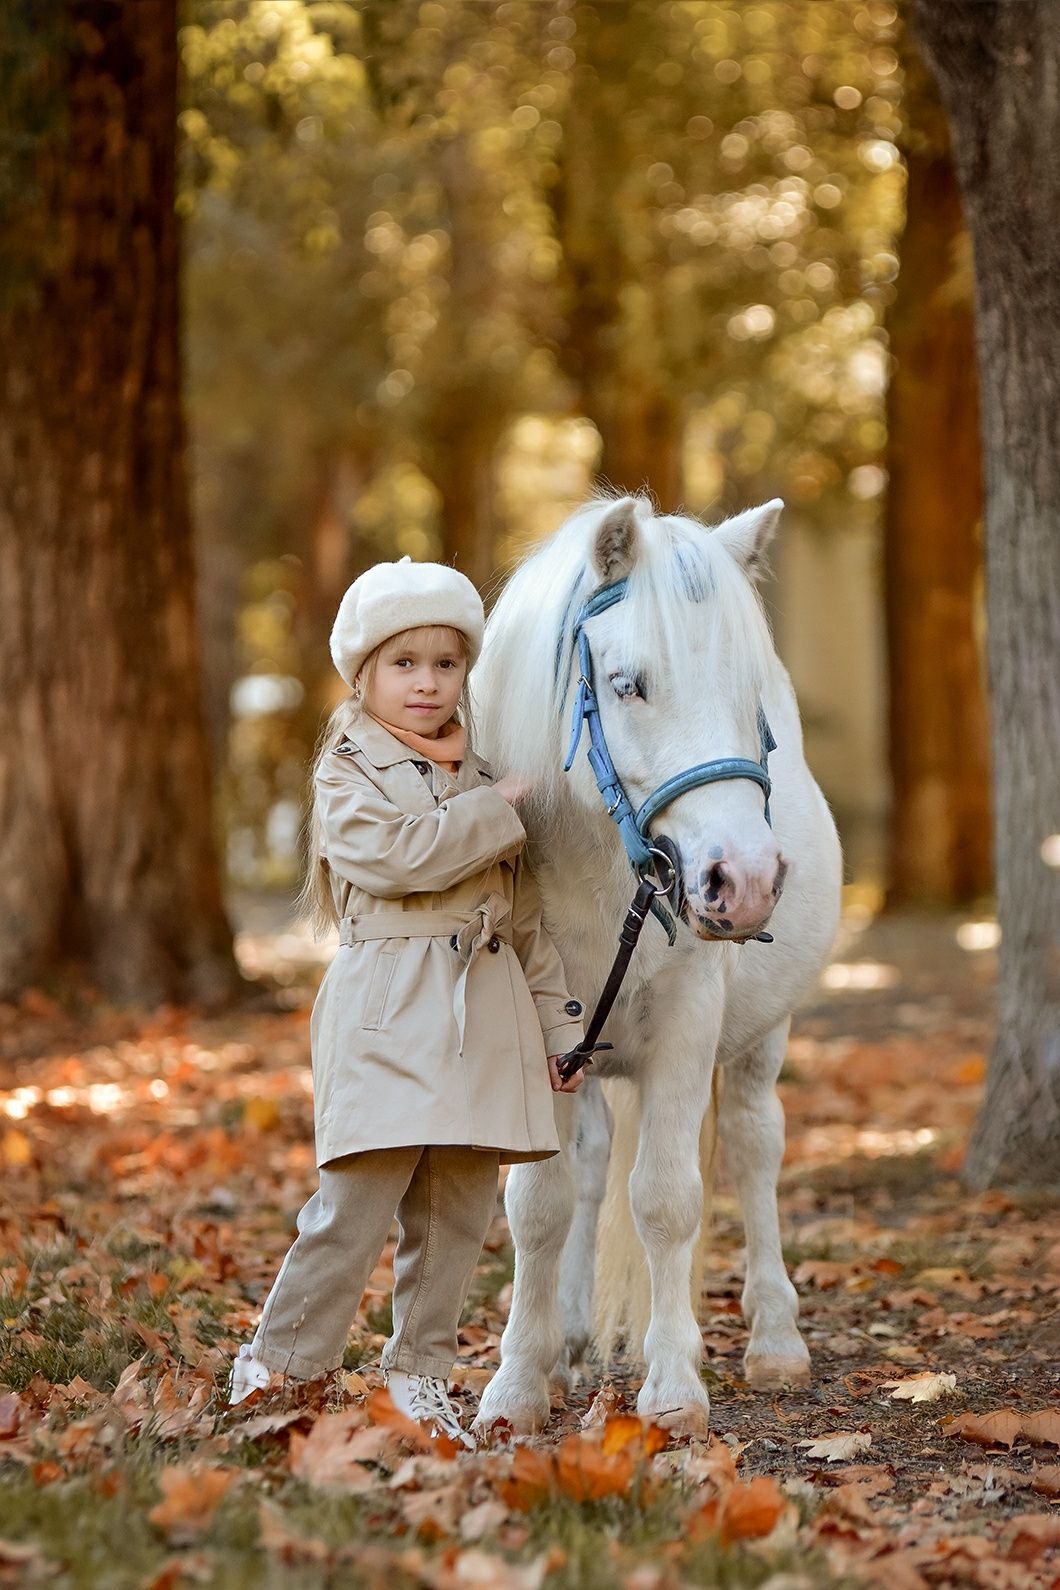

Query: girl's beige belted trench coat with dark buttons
[[310, 720, 582, 1165]]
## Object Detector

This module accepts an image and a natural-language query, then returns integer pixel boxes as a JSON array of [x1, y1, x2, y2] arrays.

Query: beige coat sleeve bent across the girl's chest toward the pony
[[315, 758, 526, 900]]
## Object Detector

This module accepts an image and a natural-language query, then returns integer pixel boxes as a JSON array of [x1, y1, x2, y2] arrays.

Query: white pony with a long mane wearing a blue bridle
[[474, 496, 841, 1434]]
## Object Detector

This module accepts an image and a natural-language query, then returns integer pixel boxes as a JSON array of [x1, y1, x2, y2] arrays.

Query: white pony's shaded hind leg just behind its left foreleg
[[555, 1076, 612, 1383]]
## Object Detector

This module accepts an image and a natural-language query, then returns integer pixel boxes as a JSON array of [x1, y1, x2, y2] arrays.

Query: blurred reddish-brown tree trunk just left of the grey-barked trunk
[[884, 37, 993, 905]]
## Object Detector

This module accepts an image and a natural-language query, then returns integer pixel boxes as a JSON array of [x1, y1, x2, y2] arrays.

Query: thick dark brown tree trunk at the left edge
[[0, 0, 238, 1002]]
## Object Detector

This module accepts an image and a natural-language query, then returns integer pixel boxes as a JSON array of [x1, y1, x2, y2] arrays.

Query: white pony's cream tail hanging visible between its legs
[[593, 1065, 721, 1364]]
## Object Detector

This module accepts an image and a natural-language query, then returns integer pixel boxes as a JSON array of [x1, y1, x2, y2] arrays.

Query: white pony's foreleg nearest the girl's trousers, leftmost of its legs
[[475, 1094, 574, 1434]]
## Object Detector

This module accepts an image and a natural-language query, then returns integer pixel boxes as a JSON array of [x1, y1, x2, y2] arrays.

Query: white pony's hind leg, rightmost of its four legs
[[720, 1021, 810, 1390]]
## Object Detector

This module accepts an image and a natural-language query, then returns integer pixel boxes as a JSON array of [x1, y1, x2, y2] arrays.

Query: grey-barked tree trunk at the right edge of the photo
[[917, 0, 1060, 1186]]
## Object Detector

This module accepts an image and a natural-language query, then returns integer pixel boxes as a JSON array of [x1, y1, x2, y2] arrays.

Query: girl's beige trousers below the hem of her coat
[[251, 1146, 499, 1380]]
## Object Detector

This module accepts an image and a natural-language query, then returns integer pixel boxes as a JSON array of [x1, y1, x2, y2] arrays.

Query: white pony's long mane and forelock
[[472, 498, 776, 808]]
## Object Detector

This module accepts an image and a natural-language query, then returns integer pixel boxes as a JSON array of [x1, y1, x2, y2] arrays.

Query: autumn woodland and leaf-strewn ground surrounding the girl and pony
[[0, 0, 1060, 1590]]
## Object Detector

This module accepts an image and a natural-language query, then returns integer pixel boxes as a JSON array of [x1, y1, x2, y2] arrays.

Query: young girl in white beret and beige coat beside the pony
[[230, 558, 582, 1445]]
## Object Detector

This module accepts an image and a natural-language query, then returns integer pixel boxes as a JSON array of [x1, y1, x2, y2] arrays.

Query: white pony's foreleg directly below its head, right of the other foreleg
[[629, 1045, 714, 1436]]
